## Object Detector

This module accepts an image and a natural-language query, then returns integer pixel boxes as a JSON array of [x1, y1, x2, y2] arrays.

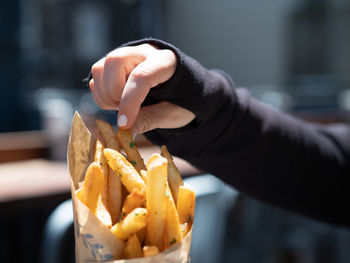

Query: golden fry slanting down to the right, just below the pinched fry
[[103, 148, 146, 195]]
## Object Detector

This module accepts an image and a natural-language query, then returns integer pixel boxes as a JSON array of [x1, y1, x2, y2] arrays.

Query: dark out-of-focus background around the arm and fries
[[0, 0, 350, 263]]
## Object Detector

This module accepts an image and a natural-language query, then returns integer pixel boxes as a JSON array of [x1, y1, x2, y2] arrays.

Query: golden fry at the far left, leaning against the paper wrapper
[[76, 162, 103, 214]]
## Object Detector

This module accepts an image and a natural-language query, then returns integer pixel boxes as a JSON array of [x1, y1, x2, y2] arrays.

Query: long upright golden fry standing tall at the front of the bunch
[[146, 154, 168, 251]]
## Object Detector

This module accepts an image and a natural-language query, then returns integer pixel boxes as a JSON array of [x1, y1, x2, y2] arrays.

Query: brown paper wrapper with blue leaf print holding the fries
[[67, 112, 192, 263]]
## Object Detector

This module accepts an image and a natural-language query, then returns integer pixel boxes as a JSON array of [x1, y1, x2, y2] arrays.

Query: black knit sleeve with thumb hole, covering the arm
[[94, 39, 350, 225]]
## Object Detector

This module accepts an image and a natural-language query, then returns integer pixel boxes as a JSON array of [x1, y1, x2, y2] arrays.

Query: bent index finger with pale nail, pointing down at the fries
[[118, 50, 176, 128]]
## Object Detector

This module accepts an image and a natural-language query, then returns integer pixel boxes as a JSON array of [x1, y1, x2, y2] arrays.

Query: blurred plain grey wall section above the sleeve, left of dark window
[[166, 0, 295, 86]]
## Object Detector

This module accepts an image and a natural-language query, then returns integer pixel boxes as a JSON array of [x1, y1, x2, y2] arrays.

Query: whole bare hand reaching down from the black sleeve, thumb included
[[89, 44, 195, 134]]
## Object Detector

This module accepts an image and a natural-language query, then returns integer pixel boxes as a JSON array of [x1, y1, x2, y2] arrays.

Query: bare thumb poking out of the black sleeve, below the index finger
[[131, 102, 195, 135]]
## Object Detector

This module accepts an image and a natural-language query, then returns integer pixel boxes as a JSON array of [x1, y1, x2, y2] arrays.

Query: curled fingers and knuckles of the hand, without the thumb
[[89, 44, 176, 131]]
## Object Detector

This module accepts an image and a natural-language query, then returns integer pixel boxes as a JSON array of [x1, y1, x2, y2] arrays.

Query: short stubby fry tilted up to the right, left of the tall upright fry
[[111, 208, 148, 240]]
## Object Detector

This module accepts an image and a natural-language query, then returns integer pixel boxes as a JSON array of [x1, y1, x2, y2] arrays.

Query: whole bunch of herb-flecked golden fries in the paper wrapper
[[75, 121, 195, 259]]
